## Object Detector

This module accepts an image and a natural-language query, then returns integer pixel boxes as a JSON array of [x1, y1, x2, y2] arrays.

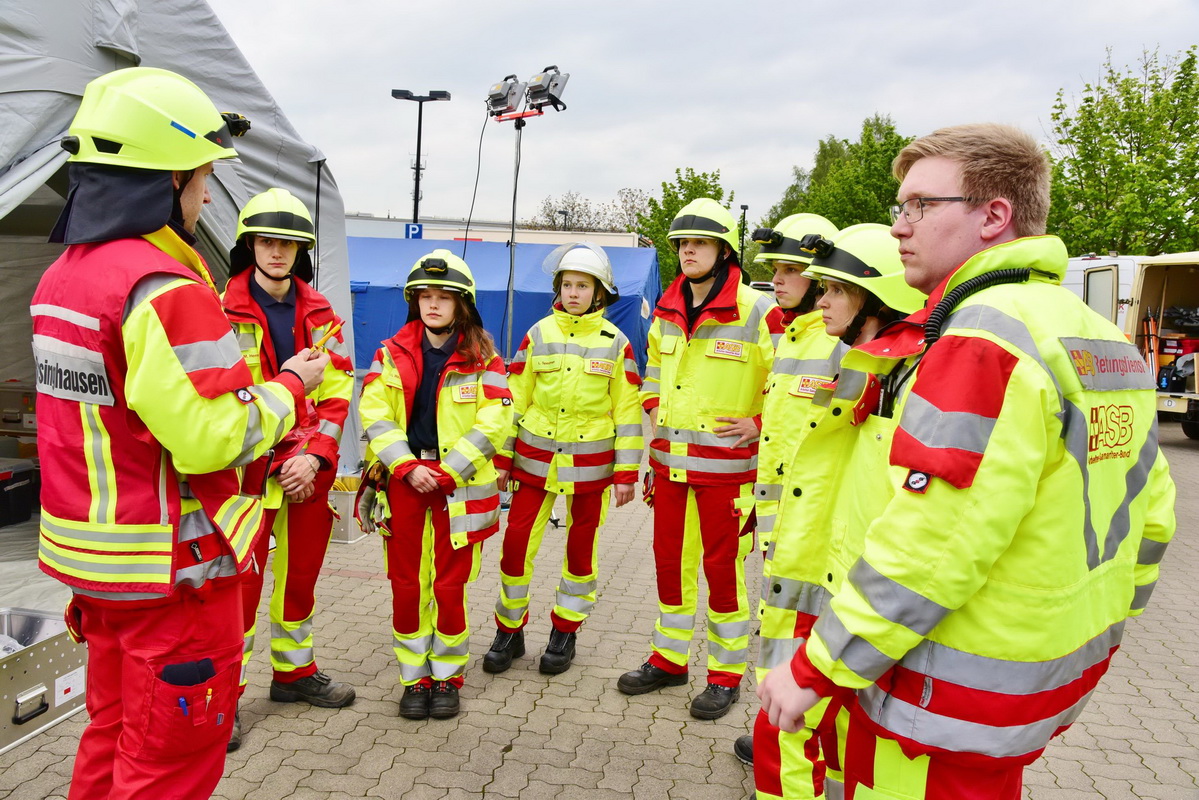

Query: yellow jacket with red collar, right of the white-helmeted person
[[641, 266, 783, 489]]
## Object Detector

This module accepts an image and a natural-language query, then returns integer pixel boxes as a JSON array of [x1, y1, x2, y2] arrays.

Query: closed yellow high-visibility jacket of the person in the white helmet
[[495, 307, 641, 494]]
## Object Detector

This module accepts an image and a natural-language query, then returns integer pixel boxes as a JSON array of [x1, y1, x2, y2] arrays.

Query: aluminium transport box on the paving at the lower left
[[0, 608, 88, 753]]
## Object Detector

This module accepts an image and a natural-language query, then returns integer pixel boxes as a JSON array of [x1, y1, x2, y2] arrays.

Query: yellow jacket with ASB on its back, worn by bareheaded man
[[784, 236, 1175, 763]]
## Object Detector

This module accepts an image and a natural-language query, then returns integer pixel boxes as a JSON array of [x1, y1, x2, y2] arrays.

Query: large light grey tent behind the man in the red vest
[[0, 0, 361, 469]]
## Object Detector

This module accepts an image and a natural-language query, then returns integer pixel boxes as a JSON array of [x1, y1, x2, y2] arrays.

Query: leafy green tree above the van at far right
[[1049, 47, 1199, 254]]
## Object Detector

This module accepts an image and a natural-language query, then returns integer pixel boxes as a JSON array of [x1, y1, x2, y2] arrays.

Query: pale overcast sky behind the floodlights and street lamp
[[201, 0, 1199, 224]]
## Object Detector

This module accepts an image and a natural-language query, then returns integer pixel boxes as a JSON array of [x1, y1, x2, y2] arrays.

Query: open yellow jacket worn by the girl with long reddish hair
[[359, 319, 512, 548]]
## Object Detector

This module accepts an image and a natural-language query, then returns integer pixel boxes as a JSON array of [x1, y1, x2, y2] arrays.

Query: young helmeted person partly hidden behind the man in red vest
[[222, 188, 355, 751]]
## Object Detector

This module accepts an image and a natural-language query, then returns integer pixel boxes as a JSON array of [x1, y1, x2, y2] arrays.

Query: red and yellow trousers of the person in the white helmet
[[495, 483, 611, 633]]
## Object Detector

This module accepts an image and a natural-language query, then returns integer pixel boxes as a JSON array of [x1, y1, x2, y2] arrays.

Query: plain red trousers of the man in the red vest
[[67, 577, 241, 800]]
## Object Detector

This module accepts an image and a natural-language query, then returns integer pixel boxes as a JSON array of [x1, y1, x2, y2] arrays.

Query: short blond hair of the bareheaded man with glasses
[[891, 122, 1049, 236]]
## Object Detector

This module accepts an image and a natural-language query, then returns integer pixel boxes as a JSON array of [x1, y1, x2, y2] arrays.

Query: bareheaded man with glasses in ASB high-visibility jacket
[[759, 125, 1175, 800]]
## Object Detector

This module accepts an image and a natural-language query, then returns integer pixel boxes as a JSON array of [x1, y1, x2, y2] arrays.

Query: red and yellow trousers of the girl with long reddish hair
[[384, 477, 482, 686]]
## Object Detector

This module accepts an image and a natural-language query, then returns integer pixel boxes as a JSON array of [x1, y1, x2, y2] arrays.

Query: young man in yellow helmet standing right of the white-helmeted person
[[617, 198, 783, 720]]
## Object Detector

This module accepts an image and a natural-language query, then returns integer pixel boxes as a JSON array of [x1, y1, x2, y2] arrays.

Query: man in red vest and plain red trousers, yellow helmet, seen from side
[[30, 67, 329, 800]]
